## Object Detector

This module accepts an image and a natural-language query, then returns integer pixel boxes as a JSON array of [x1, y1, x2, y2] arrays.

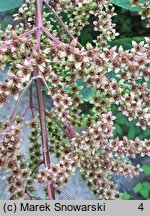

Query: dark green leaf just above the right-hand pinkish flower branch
[[109, 37, 144, 50]]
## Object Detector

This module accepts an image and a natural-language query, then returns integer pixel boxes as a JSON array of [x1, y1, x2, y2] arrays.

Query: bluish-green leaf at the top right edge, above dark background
[[112, 0, 150, 11]]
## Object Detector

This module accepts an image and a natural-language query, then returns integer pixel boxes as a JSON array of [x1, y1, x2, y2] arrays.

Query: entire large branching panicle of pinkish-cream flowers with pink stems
[[0, 0, 150, 199]]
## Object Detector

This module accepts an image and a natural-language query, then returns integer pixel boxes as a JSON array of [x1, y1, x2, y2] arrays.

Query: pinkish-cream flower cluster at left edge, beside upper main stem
[[0, 39, 33, 107]]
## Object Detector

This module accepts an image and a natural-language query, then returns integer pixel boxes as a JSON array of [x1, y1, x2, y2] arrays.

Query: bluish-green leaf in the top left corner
[[0, 0, 23, 12]]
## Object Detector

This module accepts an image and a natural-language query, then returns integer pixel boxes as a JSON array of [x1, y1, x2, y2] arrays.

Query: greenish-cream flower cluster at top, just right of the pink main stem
[[44, 0, 118, 48]]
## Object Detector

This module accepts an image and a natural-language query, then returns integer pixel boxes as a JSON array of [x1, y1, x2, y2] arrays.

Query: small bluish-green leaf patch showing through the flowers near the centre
[[77, 79, 95, 101]]
